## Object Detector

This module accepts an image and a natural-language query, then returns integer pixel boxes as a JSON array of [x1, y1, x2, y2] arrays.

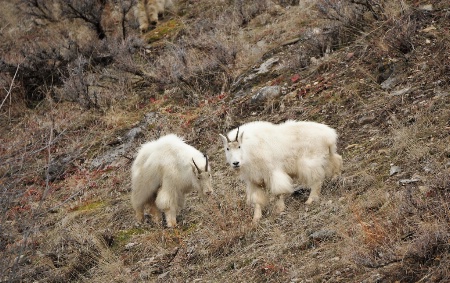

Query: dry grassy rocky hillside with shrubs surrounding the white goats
[[0, 0, 450, 282]]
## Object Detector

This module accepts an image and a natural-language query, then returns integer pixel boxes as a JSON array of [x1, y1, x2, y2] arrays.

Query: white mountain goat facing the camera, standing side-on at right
[[220, 121, 342, 223]]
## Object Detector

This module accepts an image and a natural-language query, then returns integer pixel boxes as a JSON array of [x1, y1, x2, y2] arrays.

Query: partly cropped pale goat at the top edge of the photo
[[134, 0, 173, 33]]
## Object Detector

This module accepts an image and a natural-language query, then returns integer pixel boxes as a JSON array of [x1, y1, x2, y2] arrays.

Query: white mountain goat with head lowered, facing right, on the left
[[131, 134, 212, 227]]
